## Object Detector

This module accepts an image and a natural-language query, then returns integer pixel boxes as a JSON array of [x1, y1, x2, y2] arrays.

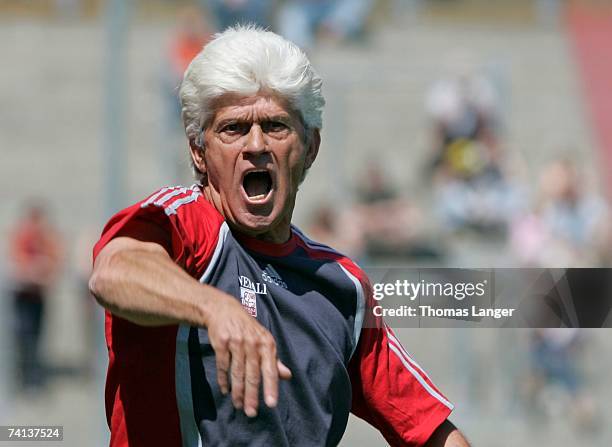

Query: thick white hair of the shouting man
[[179, 25, 325, 146]]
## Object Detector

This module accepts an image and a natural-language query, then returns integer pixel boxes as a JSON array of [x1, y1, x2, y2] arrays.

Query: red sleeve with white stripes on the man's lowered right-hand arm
[[349, 288, 453, 446]]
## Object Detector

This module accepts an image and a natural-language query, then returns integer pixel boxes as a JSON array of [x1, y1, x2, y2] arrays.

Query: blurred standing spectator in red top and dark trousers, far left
[[10, 203, 61, 389]]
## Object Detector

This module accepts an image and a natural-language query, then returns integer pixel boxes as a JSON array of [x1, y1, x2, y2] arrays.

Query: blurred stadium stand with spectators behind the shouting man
[[0, 0, 612, 447]]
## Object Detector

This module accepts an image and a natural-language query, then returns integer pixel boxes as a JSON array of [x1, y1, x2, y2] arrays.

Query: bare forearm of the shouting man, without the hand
[[89, 237, 224, 326]]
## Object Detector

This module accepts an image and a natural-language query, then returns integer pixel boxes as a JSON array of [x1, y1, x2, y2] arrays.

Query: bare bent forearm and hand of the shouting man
[[89, 237, 291, 416]]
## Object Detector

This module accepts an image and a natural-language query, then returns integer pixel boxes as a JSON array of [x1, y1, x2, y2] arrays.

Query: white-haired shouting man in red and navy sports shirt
[[90, 27, 467, 446]]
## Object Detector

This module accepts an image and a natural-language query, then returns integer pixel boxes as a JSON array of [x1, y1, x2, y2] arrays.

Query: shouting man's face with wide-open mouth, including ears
[[192, 94, 319, 243]]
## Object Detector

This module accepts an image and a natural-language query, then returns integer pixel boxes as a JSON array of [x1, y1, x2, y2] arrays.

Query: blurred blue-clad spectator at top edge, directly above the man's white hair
[[205, 0, 277, 31]]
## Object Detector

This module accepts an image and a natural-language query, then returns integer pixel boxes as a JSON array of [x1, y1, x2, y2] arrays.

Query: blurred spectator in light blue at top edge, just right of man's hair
[[278, 0, 374, 48]]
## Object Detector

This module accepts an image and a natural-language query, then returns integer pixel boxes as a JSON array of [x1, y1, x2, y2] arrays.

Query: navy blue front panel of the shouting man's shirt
[[184, 227, 361, 446]]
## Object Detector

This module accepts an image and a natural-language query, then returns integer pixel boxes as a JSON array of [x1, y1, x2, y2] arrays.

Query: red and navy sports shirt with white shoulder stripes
[[94, 185, 453, 447]]
